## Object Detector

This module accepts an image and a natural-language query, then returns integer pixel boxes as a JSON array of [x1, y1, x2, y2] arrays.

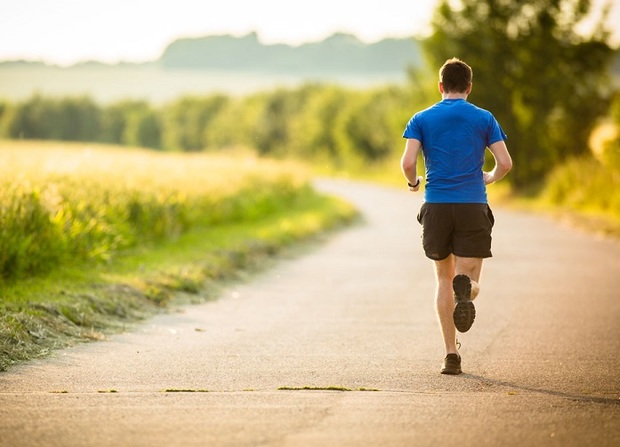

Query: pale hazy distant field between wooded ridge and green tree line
[[0, 65, 405, 104]]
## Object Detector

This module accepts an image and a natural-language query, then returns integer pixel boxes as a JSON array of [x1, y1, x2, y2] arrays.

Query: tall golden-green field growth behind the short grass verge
[[0, 142, 308, 280]]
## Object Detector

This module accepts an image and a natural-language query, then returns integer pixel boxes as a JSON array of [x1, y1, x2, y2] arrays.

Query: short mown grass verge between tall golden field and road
[[0, 194, 357, 370]]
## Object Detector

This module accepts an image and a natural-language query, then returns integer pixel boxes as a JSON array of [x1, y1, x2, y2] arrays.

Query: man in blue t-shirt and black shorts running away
[[401, 58, 512, 374]]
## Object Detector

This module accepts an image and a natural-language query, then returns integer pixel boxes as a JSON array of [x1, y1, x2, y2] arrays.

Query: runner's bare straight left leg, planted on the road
[[435, 255, 458, 354]]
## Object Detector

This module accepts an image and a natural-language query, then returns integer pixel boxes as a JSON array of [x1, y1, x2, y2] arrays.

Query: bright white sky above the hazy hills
[[0, 0, 620, 65]]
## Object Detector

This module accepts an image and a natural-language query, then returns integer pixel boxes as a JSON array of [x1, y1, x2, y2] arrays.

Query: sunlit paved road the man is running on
[[0, 181, 620, 447]]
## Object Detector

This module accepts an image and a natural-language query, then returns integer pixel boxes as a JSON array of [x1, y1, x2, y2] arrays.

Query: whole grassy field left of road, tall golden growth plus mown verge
[[0, 141, 356, 370]]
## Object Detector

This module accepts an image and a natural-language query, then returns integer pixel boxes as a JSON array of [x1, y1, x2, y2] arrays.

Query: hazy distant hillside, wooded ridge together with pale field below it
[[0, 33, 422, 103]]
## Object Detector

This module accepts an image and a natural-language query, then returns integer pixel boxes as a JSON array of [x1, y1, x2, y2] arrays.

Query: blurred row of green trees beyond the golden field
[[0, 84, 422, 168]]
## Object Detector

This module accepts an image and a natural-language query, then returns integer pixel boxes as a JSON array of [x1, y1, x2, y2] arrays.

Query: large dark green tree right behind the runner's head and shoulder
[[423, 0, 614, 185]]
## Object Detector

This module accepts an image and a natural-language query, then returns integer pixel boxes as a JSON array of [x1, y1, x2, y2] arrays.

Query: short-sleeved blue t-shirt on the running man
[[403, 99, 506, 203]]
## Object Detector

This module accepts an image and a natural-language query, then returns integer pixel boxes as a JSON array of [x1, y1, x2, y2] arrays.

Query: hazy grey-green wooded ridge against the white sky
[[159, 33, 422, 73]]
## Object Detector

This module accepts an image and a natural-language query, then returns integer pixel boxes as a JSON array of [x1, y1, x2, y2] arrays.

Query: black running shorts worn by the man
[[418, 203, 495, 261]]
